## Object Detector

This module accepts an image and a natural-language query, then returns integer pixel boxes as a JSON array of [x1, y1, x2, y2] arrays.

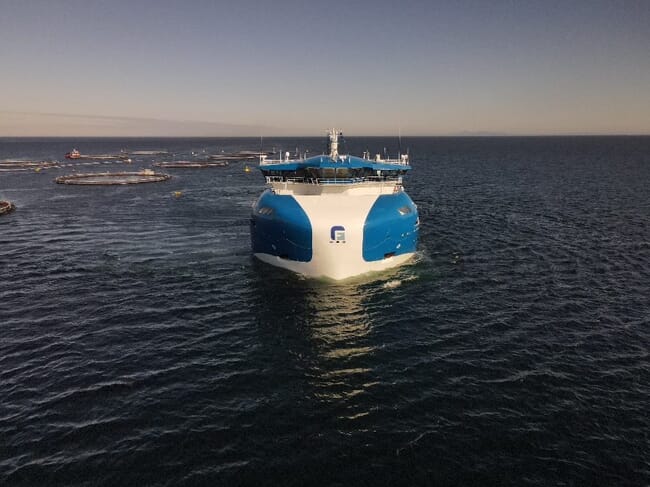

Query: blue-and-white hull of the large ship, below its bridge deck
[[253, 185, 418, 280]]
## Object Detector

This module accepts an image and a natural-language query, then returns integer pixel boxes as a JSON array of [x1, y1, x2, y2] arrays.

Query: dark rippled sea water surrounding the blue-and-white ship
[[0, 137, 650, 486]]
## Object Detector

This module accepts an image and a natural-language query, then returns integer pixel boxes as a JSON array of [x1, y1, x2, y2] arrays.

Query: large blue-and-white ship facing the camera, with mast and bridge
[[251, 129, 420, 280]]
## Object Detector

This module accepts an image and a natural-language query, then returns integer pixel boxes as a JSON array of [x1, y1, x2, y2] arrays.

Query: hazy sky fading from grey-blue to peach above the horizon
[[0, 0, 650, 136]]
